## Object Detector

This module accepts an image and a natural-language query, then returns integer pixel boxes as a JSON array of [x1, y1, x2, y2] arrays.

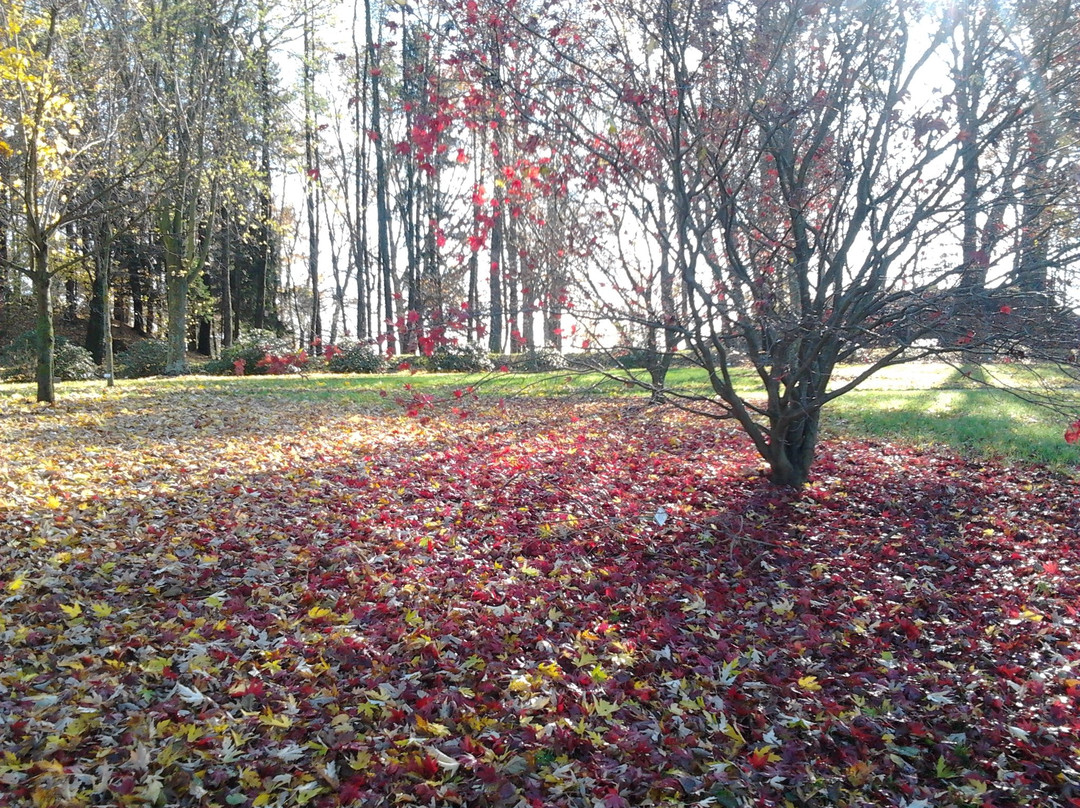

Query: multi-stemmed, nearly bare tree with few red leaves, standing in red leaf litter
[[453, 0, 1036, 487]]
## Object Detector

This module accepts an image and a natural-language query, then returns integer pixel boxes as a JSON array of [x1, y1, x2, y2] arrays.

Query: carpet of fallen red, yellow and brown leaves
[[0, 389, 1080, 808]]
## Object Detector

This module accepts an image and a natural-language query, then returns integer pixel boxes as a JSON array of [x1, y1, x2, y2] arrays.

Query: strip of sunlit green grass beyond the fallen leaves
[[0, 363, 1080, 472]]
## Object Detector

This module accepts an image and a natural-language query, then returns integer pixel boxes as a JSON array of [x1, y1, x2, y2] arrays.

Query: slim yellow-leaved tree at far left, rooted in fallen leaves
[[0, 4, 140, 403]]
